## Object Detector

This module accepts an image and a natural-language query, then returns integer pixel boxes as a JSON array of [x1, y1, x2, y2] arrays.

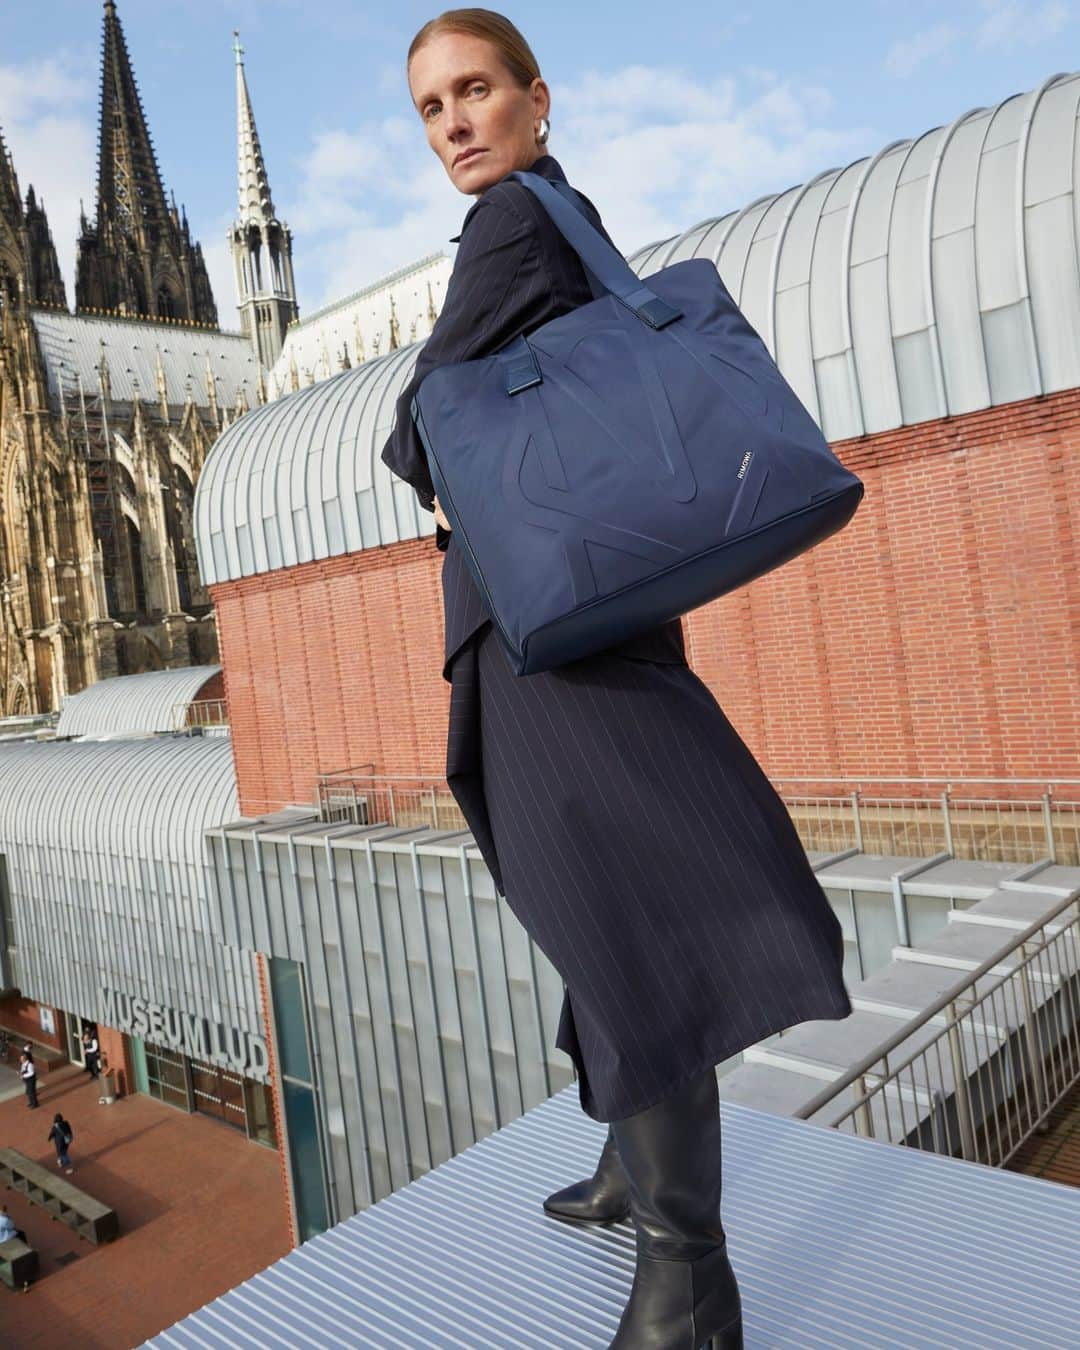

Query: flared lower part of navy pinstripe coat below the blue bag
[[459, 628, 852, 1121]]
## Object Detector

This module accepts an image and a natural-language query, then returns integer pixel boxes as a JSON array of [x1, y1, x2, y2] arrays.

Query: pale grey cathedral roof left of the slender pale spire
[[30, 309, 259, 408]]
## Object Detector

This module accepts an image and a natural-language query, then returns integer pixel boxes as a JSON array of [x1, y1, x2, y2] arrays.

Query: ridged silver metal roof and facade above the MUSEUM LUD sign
[[0, 736, 262, 1034]]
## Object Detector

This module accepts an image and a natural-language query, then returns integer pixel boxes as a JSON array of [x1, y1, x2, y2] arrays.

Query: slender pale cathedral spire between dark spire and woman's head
[[230, 31, 297, 370]]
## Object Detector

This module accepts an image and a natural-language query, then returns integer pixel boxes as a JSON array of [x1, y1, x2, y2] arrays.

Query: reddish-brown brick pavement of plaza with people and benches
[[0, 1065, 289, 1350]]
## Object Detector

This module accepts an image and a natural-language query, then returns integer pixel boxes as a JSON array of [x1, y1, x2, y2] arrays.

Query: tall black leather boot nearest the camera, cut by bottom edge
[[610, 1069, 743, 1350]]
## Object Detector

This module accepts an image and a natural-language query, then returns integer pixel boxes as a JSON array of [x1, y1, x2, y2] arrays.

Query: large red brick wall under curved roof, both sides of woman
[[213, 390, 1080, 811]]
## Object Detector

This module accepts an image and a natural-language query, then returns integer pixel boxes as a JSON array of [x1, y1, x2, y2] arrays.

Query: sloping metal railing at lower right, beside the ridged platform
[[792, 890, 1080, 1166]]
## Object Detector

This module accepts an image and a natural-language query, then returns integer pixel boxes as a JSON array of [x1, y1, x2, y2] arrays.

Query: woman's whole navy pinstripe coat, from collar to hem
[[382, 155, 852, 1121]]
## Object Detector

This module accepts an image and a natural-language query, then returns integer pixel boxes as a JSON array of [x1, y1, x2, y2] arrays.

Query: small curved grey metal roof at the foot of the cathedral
[[57, 666, 221, 736]]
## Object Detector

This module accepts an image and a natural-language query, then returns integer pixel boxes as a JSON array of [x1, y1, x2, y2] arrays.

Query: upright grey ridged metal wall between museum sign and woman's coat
[[209, 811, 571, 1222]]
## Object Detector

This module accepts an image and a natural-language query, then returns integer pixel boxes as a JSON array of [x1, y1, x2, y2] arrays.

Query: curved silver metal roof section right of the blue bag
[[630, 73, 1080, 440]]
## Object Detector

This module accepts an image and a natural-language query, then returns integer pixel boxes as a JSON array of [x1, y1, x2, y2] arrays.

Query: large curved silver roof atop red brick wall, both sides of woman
[[196, 74, 1080, 583]]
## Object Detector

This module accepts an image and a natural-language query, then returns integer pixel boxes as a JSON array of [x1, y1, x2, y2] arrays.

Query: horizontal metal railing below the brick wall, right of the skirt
[[775, 778, 1080, 865]]
